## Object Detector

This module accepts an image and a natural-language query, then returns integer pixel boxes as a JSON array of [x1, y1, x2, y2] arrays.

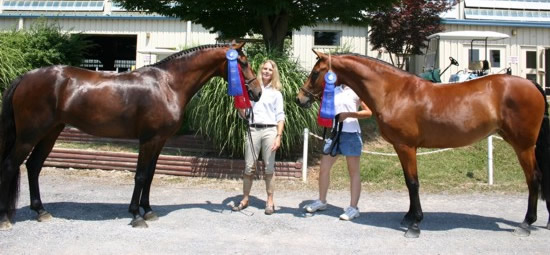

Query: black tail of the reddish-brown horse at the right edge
[[534, 83, 550, 200]]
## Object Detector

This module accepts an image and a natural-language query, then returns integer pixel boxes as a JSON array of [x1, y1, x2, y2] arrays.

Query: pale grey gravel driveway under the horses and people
[[0, 168, 550, 254]]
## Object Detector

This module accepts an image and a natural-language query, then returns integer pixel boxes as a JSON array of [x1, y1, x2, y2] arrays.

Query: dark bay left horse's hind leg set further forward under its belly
[[26, 124, 65, 222]]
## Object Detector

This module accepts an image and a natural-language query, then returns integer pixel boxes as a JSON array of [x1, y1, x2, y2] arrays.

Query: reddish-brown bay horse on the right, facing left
[[297, 52, 550, 237]]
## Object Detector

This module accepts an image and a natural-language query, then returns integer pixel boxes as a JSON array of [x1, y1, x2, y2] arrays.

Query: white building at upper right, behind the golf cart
[[413, 0, 550, 87]]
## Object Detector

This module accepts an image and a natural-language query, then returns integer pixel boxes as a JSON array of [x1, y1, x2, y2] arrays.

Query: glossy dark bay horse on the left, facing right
[[0, 43, 261, 230]]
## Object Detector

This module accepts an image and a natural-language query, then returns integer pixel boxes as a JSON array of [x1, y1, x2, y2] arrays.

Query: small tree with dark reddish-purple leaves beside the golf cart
[[369, 0, 454, 68]]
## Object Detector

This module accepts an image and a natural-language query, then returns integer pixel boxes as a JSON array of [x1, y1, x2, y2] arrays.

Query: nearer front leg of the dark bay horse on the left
[[128, 137, 166, 228]]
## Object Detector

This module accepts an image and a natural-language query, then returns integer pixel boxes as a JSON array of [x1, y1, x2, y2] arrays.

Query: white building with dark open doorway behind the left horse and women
[[0, 0, 367, 71]]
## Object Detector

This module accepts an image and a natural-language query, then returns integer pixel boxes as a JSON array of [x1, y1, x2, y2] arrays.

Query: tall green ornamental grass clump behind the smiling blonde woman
[[187, 45, 319, 160]]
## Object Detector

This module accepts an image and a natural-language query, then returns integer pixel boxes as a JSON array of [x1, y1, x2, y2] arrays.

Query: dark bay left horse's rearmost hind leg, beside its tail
[[0, 140, 33, 230]]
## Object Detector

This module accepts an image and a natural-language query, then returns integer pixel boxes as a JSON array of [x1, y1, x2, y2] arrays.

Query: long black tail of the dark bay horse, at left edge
[[0, 76, 21, 218]]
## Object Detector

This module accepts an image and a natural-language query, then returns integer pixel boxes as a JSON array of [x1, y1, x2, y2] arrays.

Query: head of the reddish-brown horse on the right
[[296, 50, 329, 108]]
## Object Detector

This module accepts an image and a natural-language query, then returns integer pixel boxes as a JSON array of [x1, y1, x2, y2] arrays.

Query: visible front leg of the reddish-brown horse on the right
[[394, 145, 424, 238]]
